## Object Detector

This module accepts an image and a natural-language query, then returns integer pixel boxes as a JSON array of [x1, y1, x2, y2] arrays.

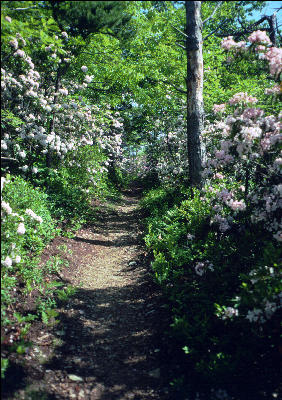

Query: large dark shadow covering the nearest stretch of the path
[[43, 277, 169, 400]]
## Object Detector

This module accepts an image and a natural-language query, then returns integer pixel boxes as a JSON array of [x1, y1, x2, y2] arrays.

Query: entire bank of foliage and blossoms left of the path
[[1, 2, 126, 382]]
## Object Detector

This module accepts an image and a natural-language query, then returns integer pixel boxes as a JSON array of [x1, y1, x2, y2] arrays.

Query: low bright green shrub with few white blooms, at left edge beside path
[[1, 175, 68, 378]]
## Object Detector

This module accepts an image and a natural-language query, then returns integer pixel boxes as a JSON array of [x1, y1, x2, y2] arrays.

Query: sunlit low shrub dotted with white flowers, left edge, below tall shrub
[[1, 175, 56, 373]]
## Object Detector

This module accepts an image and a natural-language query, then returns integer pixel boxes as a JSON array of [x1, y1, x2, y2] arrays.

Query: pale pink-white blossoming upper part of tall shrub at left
[[1, 15, 123, 186]]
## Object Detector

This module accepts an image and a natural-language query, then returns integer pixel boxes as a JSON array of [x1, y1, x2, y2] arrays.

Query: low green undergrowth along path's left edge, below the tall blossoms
[[1, 156, 120, 378]]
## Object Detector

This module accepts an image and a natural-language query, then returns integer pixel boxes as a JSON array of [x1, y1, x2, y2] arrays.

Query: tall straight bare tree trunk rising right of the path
[[185, 1, 204, 187]]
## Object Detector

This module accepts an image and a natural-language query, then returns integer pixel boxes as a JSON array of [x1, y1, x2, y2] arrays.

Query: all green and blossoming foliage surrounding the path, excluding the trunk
[[1, 1, 282, 399]]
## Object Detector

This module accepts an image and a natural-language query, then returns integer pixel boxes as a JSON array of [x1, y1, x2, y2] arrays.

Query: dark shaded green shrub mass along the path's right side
[[142, 184, 281, 396]]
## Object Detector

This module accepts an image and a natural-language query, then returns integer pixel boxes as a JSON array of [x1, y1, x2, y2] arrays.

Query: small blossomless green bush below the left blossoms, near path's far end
[[29, 145, 118, 229]]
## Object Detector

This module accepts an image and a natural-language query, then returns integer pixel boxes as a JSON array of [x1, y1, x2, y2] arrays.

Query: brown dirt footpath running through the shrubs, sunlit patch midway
[[2, 191, 173, 400]]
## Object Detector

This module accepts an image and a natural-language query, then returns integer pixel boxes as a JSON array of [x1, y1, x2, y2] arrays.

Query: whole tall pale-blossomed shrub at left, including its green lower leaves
[[1, 12, 128, 232]]
